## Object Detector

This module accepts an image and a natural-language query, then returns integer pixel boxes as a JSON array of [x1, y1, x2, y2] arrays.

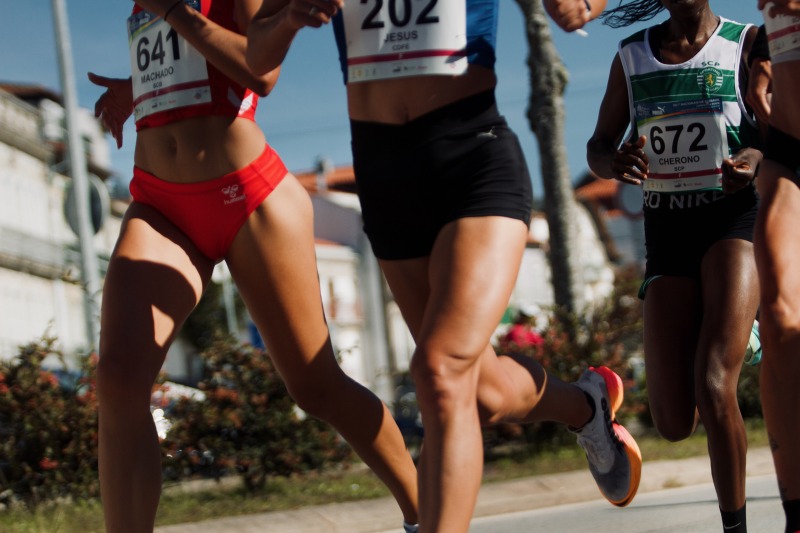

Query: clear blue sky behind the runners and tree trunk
[[0, 0, 761, 197]]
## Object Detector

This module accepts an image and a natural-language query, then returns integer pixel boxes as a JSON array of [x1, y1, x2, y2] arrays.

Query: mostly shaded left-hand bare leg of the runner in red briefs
[[97, 203, 213, 533]]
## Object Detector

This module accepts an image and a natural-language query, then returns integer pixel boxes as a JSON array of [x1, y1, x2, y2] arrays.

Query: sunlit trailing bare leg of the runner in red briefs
[[222, 176, 417, 523]]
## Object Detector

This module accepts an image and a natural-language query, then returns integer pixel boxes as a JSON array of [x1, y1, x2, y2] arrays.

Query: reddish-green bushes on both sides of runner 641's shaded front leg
[[0, 332, 352, 508]]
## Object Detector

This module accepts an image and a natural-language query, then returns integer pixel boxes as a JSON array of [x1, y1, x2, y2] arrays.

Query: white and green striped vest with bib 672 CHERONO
[[619, 18, 755, 197]]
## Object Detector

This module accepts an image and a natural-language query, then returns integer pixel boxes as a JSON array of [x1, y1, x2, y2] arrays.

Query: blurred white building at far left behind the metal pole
[[0, 85, 120, 358]]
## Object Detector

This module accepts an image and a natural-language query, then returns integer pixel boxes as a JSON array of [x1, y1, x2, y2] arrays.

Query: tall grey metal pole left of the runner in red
[[53, 0, 100, 351]]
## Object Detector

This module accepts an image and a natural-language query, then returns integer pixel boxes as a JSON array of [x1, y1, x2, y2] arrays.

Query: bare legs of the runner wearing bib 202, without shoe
[[381, 217, 591, 533]]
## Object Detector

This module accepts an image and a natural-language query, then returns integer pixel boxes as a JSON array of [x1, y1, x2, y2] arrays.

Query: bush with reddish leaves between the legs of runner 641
[[163, 340, 351, 490]]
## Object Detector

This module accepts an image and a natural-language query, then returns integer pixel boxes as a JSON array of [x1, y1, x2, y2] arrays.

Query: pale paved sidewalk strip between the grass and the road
[[156, 448, 775, 533]]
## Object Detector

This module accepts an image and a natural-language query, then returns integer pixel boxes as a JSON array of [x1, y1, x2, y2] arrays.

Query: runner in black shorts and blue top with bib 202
[[247, 0, 641, 533]]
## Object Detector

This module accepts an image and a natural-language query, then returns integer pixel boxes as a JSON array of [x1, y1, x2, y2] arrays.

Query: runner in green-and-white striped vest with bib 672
[[587, 0, 761, 532]]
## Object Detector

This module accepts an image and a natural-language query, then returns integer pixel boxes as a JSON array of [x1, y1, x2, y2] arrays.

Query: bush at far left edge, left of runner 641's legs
[[0, 338, 99, 507]]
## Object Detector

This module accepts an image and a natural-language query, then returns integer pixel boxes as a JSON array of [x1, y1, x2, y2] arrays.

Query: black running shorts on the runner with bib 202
[[350, 91, 532, 259]]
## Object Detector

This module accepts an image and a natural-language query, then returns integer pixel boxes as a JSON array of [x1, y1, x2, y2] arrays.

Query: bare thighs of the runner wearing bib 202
[[381, 217, 527, 358]]
